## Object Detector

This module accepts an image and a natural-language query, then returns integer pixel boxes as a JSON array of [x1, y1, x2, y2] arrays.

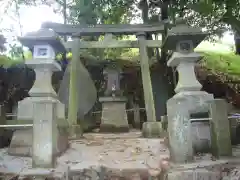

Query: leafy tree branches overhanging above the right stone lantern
[[170, 0, 240, 36]]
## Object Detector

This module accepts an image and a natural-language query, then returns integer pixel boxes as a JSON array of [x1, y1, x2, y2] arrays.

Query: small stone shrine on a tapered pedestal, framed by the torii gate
[[99, 63, 129, 132]]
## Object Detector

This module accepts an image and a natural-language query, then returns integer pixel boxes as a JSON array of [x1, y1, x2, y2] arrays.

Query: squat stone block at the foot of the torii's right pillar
[[142, 121, 163, 138]]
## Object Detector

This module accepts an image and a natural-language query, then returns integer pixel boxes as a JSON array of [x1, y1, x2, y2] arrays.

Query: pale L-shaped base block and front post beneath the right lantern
[[167, 91, 213, 163]]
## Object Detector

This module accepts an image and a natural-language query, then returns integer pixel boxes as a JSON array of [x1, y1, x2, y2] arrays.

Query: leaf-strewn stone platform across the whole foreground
[[0, 131, 240, 180]]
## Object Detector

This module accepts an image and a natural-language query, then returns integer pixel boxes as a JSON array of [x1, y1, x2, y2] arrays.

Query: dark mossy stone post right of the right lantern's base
[[210, 99, 232, 158]]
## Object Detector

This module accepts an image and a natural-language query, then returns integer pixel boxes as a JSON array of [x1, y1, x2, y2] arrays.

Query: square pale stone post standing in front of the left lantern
[[32, 98, 68, 168]]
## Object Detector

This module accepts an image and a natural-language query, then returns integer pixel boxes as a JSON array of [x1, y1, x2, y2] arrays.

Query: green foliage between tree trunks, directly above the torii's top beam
[[68, 0, 133, 25]]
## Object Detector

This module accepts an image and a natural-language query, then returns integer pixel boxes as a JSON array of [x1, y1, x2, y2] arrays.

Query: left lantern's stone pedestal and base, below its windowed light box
[[8, 60, 68, 167]]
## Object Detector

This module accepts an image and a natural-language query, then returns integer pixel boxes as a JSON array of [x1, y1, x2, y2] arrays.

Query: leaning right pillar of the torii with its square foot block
[[137, 33, 162, 138]]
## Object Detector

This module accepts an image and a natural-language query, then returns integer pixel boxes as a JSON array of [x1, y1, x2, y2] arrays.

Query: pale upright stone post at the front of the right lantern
[[167, 98, 193, 163]]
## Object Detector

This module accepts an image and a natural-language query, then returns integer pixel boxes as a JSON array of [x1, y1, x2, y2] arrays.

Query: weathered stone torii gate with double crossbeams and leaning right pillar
[[42, 23, 164, 137]]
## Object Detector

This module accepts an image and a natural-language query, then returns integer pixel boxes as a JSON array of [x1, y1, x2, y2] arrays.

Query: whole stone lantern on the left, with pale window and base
[[9, 29, 68, 167]]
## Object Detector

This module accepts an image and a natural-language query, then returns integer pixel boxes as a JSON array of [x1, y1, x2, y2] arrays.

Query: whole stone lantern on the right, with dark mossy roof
[[163, 20, 213, 163]]
